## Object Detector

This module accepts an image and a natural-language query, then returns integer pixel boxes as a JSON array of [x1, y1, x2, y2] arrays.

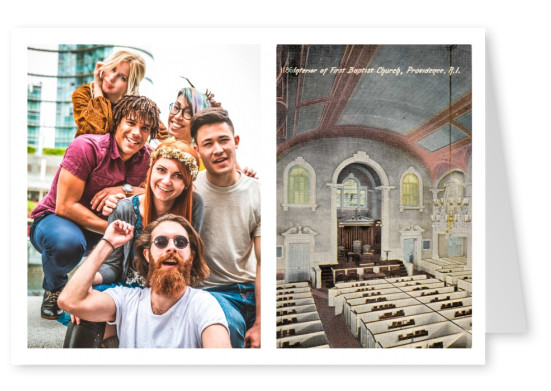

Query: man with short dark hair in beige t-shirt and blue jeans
[[190, 108, 261, 348]]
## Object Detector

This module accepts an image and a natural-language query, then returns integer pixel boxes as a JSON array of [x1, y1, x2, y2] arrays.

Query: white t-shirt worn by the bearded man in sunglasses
[[105, 286, 228, 348]]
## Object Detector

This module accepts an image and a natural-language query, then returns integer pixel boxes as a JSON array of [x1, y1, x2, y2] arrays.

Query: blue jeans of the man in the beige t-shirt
[[205, 284, 256, 348]]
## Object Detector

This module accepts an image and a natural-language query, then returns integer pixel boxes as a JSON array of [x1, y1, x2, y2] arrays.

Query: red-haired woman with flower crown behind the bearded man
[[60, 140, 203, 347]]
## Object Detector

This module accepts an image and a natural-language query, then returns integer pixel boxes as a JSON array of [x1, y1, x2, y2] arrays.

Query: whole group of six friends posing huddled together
[[29, 50, 261, 348]]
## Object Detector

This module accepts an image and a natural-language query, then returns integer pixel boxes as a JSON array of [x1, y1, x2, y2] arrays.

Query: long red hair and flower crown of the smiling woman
[[143, 139, 198, 227]]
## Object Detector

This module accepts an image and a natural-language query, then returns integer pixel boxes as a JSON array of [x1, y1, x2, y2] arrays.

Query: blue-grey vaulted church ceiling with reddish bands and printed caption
[[277, 45, 472, 181]]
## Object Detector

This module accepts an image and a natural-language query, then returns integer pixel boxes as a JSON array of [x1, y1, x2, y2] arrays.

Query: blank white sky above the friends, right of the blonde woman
[[140, 43, 264, 172]]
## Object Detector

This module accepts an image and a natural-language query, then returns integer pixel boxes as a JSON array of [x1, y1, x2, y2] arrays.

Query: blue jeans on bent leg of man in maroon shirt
[[29, 214, 102, 291]]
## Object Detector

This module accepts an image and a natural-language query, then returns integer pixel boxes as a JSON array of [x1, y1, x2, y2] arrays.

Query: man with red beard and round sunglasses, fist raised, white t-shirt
[[59, 214, 231, 348]]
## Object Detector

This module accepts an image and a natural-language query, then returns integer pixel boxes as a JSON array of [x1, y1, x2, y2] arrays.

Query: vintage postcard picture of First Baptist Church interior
[[276, 45, 474, 348]]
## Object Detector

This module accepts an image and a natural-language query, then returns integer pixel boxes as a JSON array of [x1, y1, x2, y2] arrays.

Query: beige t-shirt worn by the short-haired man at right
[[194, 171, 261, 288]]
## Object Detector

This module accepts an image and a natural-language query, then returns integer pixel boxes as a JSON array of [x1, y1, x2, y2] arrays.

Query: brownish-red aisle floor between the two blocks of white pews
[[312, 288, 361, 348]]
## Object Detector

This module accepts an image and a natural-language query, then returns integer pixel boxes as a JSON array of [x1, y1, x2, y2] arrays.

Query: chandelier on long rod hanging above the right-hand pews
[[431, 45, 471, 236]]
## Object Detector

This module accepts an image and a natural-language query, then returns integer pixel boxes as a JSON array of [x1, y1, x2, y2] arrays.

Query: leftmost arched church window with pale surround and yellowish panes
[[282, 157, 318, 211]]
